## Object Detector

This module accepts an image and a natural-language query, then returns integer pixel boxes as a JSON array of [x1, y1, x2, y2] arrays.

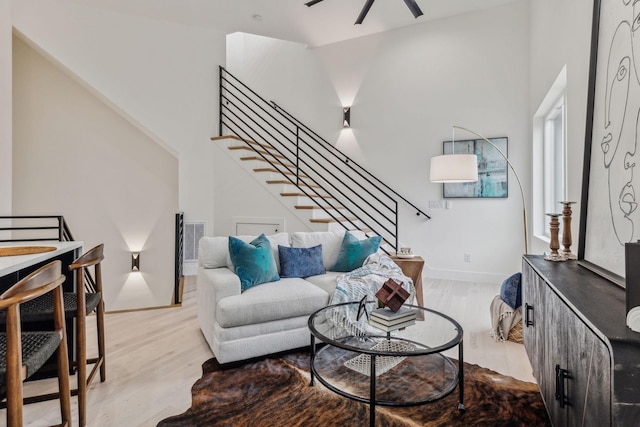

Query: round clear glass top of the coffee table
[[309, 301, 463, 356]]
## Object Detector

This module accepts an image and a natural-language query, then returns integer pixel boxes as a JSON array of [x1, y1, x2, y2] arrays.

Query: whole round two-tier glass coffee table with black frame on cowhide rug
[[309, 301, 464, 426]]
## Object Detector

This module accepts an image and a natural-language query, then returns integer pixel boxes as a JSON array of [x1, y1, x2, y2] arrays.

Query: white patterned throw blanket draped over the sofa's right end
[[327, 254, 416, 336]]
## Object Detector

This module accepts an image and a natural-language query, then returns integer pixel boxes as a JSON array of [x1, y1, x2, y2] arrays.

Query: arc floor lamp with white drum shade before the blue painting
[[429, 126, 529, 254]]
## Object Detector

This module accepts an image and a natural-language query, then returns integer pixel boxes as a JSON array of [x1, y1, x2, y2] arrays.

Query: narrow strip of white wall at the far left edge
[[0, 0, 12, 215]]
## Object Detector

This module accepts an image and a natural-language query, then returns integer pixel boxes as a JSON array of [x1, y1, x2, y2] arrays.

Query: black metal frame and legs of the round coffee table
[[308, 301, 465, 427]]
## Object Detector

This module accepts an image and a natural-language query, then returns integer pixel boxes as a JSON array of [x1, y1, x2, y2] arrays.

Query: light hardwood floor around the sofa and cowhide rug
[[0, 277, 535, 427]]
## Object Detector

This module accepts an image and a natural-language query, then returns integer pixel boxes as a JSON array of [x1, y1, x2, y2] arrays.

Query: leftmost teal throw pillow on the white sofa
[[229, 234, 280, 292]]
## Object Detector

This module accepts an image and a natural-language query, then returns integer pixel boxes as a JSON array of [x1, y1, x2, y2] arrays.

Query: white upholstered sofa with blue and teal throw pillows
[[197, 231, 366, 363]]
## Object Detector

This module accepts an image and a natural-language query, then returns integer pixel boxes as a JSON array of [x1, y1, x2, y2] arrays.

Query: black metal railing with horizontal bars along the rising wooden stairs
[[219, 67, 430, 250]]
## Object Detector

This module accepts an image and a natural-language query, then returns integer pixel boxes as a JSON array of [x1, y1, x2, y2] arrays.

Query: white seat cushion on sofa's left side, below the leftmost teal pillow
[[216, 278, 329, 328]]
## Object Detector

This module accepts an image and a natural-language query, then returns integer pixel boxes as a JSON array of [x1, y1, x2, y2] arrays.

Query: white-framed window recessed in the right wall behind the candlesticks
[[533, 68, 567, 240]]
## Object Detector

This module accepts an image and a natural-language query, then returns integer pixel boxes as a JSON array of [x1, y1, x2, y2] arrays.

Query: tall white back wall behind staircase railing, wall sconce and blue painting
[[225, 2, 531, 281]]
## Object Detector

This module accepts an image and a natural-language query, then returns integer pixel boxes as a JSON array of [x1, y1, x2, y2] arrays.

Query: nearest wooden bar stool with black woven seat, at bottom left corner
[[0, 261, 71, 427]]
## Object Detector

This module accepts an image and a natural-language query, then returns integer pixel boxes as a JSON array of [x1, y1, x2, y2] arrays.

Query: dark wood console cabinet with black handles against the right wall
[[522, 255, 640, 426]]
